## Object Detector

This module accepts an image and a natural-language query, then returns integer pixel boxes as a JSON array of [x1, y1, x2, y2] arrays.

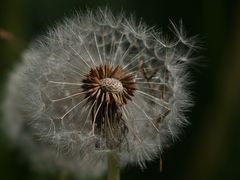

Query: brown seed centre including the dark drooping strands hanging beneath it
[[81, 65, 136, 149]]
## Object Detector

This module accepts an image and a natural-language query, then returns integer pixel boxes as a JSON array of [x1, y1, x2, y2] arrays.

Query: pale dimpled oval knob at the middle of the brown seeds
[[100, 78, 123, 93]]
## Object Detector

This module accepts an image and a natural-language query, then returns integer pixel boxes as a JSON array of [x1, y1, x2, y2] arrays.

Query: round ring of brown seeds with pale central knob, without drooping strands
[[82, 65, 136, 107]]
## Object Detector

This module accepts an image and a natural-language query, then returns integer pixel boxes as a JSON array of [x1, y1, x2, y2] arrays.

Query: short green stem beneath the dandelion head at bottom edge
[[108, 153, 120, 180]]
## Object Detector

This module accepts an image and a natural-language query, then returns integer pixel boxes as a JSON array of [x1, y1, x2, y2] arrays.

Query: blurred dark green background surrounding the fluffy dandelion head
[[0, 0, 240, 180]]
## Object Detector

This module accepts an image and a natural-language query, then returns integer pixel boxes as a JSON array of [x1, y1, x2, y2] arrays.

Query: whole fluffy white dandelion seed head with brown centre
[[2, 9, 195, 179]]
